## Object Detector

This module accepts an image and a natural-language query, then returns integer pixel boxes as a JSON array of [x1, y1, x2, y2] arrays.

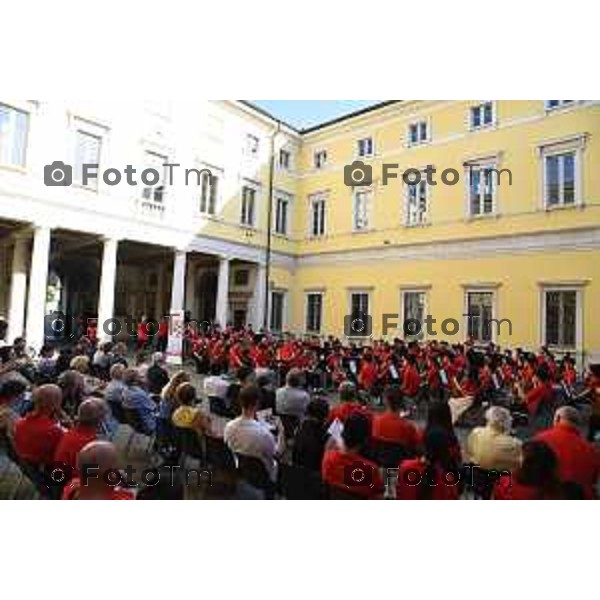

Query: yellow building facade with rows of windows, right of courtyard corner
[[251, 100, 600, 360]]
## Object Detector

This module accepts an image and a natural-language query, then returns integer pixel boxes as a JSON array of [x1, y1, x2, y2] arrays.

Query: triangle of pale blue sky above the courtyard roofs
[[250, 100, 380, 129]]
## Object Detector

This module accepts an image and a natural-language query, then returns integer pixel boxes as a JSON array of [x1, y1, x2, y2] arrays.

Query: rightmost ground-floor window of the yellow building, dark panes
[[544, 290, 578, 348]]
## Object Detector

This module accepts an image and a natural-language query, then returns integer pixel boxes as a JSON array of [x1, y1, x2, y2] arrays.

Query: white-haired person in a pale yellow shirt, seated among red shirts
[[467, 406, 521, 471]]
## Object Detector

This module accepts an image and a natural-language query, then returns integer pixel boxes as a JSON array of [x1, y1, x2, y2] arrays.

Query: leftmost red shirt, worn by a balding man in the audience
[[15, 412, 64, 465]]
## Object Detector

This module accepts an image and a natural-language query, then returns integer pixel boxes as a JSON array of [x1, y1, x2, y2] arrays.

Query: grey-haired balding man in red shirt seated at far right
[[535, 406, 600, 499]]
